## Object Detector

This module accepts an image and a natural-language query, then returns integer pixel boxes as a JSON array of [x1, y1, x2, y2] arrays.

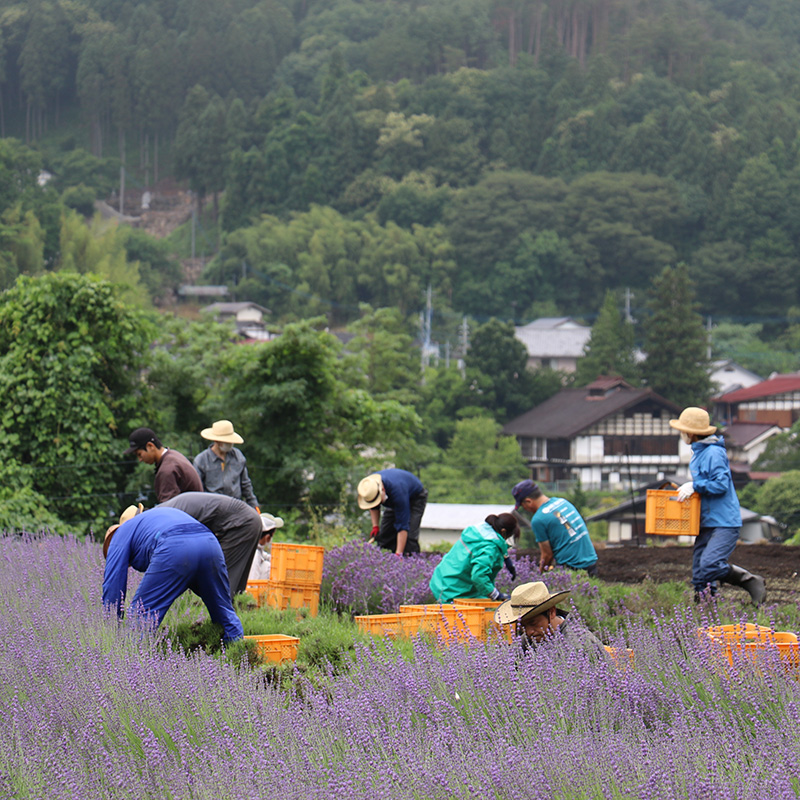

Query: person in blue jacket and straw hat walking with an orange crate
[[669, 406, 767, 605]]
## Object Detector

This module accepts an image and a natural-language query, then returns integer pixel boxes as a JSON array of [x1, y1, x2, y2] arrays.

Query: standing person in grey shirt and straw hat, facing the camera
[[194, 419, 260, 511]]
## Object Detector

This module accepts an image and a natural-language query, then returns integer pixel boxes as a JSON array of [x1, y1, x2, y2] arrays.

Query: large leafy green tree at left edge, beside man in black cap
[[0, 273, 151, 530]]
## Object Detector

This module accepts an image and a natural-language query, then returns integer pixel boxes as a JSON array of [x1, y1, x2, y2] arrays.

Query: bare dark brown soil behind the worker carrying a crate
[[525, 544, 800, 605]]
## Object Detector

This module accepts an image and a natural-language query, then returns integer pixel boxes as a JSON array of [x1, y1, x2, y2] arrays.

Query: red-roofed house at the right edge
[[714, 373, 800, 428]]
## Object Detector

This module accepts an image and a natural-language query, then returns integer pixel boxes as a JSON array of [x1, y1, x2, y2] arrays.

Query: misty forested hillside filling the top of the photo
[[0, 0, 800, 320]]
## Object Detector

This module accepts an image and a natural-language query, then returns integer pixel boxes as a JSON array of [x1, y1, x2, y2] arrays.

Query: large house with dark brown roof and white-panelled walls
[[503, 376, 680, 489]]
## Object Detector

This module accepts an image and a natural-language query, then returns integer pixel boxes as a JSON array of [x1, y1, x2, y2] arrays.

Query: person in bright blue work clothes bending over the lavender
[[103, 507, 244, 642]]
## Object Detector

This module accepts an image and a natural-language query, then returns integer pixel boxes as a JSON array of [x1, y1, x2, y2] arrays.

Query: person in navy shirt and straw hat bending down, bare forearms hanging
[[358, 469, 428, 556]]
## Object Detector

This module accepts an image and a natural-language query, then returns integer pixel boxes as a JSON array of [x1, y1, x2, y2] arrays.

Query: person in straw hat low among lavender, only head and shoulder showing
[[494, 581, 607, 658]]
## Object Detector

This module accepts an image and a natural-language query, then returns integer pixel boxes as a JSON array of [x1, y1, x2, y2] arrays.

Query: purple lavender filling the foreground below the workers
[[0, 538, 800, 800]]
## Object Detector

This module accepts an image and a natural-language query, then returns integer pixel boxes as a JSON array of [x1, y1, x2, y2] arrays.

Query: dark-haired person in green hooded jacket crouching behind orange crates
[[430, 514, 519, 603]]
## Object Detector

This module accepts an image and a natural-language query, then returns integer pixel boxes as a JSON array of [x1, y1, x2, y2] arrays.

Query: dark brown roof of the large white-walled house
[[503, 379, 681, 439]]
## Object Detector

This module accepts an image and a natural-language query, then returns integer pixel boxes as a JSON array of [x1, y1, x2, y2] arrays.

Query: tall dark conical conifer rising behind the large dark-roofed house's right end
[[643, 264, 712, 406]]
